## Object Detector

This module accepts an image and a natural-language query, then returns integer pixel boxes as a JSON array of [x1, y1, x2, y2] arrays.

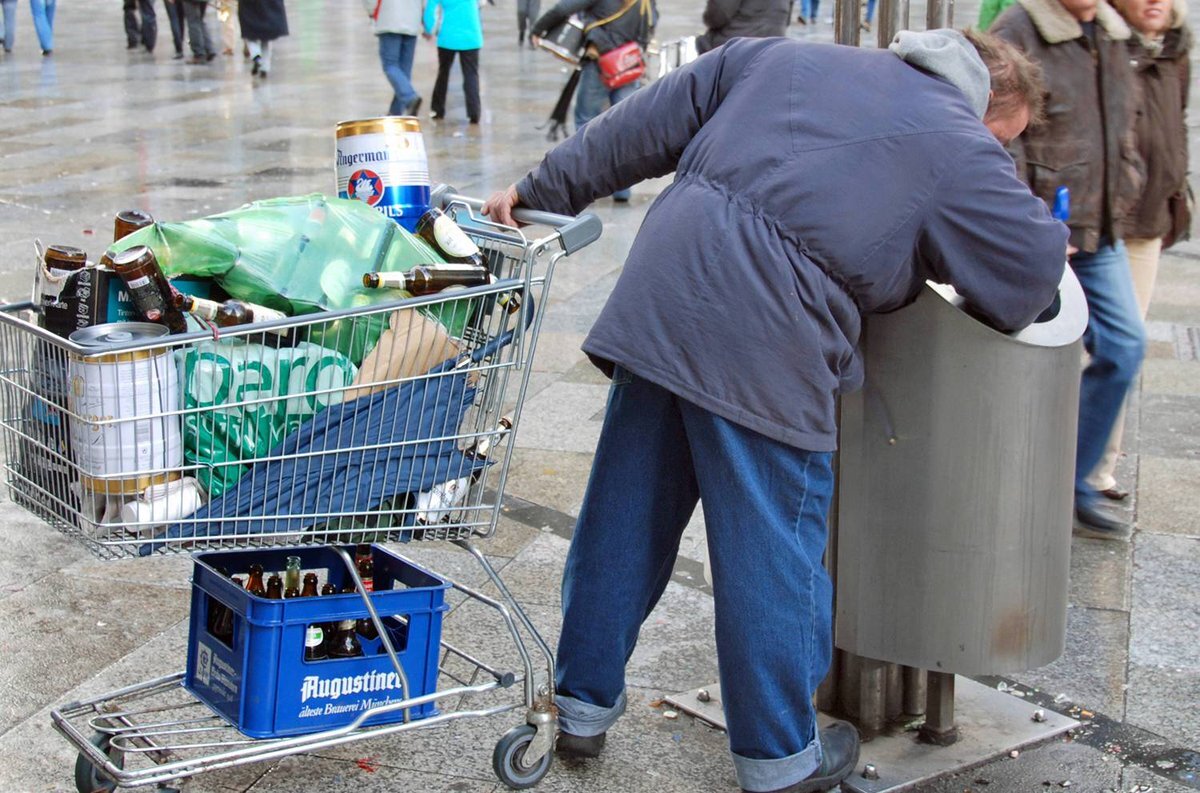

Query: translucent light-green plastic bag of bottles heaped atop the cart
[[110, 193, 473, 364]]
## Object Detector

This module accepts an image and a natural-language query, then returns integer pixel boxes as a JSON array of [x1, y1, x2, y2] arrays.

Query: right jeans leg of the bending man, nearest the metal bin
[[683, 402, 833, 791]]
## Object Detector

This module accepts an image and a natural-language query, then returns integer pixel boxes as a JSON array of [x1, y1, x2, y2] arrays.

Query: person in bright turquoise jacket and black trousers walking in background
[[422, 0, 484, 124]]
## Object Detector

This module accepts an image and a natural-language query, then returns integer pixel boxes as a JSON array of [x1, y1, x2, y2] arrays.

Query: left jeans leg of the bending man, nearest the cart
[[557, 367, 698, 735]]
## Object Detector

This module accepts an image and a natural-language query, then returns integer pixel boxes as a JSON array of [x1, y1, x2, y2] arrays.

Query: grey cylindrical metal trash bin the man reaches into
[[835, 268, 1087, 674]]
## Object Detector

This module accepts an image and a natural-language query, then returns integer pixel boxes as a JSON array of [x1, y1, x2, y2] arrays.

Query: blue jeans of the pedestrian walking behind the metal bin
[[1070, 242, 1146, 504]]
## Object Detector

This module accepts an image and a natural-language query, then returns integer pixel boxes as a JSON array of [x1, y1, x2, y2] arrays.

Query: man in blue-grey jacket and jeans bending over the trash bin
[[485, 30, 1067, 793]]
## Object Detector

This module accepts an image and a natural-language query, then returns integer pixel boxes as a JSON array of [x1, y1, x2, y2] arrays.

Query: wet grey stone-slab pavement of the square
[[0, 0, 1200, 793]]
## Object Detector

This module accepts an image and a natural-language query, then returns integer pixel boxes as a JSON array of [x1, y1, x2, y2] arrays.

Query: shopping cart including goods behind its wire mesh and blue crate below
[[0, 186, 600, 792]]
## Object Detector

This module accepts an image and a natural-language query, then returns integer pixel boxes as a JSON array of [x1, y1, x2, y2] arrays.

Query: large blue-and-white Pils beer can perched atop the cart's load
[[336, 116, 430, 232]]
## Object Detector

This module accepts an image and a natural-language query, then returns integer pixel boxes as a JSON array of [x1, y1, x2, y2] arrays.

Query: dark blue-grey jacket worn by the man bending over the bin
[[517, 38, 1067, 451]]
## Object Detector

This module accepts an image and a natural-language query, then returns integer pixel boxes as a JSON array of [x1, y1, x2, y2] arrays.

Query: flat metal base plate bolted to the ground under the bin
[[666, 677, 1079, 793]]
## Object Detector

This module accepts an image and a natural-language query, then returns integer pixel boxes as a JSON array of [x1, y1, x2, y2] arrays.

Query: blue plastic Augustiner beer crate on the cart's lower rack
[[184, 545, 450, 738]]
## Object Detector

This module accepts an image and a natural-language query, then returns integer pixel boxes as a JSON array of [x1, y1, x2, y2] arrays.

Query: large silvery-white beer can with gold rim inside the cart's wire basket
[[67, 323, 184, 494]]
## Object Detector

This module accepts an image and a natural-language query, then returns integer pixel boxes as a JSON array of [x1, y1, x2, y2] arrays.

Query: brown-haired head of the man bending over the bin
[[964, 30, 1045, 146]]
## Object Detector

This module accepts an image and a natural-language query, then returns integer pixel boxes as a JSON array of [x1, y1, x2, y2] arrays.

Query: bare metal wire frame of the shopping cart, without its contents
[[0, 185, 601, 791]]
